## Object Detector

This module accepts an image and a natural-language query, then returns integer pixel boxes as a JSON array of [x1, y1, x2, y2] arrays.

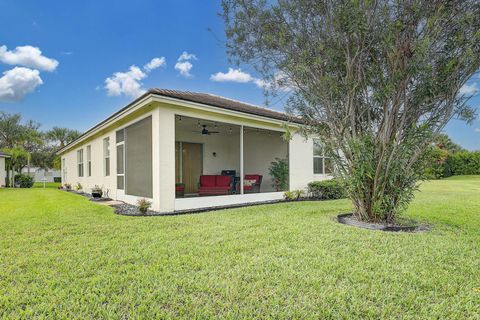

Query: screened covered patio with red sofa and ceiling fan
[[175, 114, 288, 210]]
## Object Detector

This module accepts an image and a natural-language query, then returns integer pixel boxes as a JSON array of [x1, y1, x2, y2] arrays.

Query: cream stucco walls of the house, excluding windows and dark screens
[[62, 101, 327, 212]]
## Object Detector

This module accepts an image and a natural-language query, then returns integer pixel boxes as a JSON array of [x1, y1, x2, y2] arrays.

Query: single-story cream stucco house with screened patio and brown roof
[[58, 89, 330, 212]]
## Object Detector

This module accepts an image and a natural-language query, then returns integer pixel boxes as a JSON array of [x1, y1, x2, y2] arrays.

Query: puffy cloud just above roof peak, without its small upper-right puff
[[105, 65, 147, 98]]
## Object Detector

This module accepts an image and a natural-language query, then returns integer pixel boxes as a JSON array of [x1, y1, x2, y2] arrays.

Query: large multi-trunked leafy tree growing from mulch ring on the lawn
[[222, 0, 480, 222]]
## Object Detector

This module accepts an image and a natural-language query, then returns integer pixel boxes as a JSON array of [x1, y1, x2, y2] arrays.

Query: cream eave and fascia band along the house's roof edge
[[56, 92, 301, 155]]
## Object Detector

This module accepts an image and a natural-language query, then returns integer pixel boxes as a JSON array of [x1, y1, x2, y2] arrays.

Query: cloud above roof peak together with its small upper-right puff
[[104, 57, 166, 98]]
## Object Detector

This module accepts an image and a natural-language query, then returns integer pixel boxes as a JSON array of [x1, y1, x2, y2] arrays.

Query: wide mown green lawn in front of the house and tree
[[0, 176, 480, 319]]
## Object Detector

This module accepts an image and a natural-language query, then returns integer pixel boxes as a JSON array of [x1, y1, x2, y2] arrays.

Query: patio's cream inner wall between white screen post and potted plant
[[243, 130, 288, 192]]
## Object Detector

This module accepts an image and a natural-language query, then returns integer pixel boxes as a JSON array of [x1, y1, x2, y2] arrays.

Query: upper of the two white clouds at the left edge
[[0, 46, 58, 71]]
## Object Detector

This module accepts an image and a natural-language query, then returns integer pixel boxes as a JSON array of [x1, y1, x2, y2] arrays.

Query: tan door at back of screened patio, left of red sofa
[[175, 142, 203, 194]]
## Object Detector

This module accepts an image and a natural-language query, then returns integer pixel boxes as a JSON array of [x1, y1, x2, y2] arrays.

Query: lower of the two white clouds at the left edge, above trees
[[0, 67, 43, 101]]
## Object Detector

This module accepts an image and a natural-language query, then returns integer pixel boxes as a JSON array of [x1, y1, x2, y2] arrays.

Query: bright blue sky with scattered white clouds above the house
[[0, 0, 480, 149]]
